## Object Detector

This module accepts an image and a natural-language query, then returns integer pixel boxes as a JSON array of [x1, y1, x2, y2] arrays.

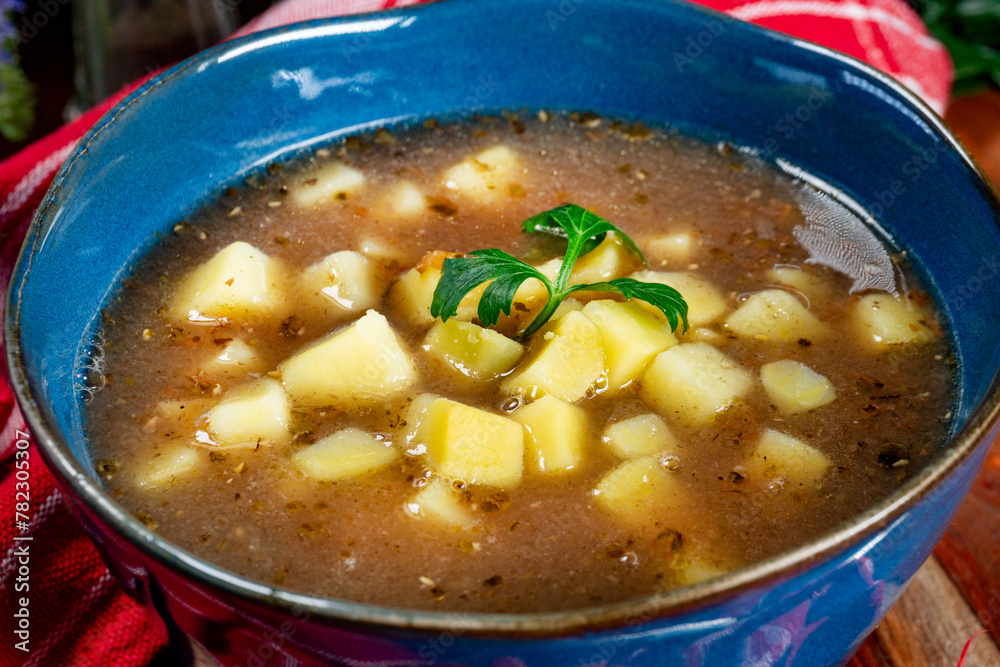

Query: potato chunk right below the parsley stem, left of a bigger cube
[[501, 311, 604, 403]]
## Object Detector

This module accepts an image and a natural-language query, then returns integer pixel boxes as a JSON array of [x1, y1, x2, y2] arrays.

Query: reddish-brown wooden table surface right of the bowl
[[848, 92, 1000, 667]]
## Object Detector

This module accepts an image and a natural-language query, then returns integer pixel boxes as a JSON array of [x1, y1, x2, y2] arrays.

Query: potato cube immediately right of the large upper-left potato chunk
[[302, 250, 382, 314]]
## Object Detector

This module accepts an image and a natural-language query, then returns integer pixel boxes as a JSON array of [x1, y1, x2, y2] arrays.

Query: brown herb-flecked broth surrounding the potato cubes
[[87, 116, 955, 612]]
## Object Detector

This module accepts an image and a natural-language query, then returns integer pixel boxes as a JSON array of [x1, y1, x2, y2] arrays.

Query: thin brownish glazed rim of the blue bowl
[[3, 0, 1000, 638]]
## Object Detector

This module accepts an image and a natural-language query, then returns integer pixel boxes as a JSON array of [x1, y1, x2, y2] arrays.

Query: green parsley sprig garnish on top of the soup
[[431, 204, 688, 338]]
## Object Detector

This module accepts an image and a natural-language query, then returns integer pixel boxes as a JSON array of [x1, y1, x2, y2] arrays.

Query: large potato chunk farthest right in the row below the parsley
[[642, 343, 753, 425]]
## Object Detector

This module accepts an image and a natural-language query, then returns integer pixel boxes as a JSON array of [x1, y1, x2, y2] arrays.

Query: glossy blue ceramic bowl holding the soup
[[5, 0, 1000, 667]]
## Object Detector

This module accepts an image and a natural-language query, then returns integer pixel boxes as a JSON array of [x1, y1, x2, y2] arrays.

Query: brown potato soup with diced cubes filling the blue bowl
[[81, 112, 956, 612]]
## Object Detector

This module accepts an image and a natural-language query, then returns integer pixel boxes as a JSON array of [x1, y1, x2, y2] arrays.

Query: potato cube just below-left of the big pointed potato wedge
[[208, 378, 292, 447]]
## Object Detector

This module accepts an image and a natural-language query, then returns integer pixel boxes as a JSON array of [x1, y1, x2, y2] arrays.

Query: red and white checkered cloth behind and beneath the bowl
[[0, 0, 952, 667]]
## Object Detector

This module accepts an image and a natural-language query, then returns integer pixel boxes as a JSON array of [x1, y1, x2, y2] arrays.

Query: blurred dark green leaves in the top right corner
[[910, 0, 1000, 96]]
